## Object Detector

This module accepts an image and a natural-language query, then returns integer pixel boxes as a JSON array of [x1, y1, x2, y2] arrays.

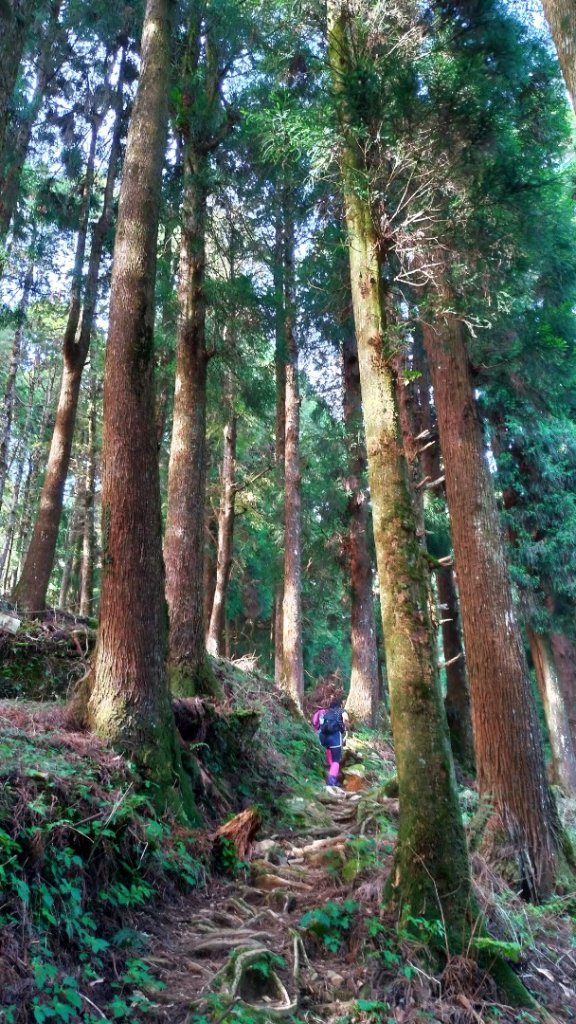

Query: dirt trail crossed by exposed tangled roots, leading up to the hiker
[[146, 790, 389, 1024]]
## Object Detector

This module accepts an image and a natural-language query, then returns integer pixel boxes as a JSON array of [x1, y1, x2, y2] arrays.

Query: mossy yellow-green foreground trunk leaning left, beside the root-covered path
[[328, 0, 471, 951]]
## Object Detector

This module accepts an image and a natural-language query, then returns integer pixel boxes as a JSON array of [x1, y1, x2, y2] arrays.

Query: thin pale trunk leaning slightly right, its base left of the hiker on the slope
[[207, 372, 237, 656]]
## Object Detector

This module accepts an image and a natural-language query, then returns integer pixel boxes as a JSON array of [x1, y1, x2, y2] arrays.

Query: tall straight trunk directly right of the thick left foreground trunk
[[164, 5, 229, 696]]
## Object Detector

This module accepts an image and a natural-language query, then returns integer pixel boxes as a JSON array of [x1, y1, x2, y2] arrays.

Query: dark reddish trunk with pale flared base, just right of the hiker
[[342, 331, 380, 729]]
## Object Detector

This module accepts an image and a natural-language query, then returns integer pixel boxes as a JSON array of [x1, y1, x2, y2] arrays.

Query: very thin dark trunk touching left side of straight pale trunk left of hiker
[[273, 211, 286, 686]]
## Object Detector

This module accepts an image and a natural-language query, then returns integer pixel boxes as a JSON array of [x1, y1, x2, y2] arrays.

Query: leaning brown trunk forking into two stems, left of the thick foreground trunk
[[14, 70, 125, 612]]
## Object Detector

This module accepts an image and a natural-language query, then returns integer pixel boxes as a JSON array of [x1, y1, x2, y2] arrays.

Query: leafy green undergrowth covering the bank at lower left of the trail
[[0, 728, 204, 1024]]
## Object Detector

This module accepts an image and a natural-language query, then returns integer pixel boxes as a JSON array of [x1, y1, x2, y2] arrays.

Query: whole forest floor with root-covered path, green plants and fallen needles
[[0, 618, 576, 1024]]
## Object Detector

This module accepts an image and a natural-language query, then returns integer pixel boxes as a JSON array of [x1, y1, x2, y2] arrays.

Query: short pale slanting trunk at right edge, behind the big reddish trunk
[[526, 626, 576, 797]]
